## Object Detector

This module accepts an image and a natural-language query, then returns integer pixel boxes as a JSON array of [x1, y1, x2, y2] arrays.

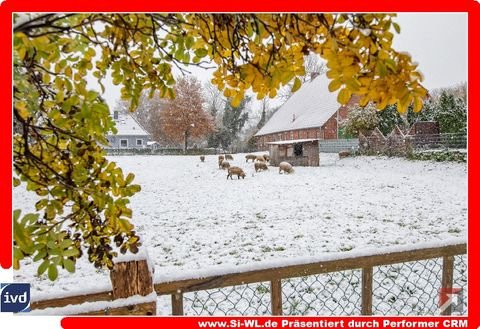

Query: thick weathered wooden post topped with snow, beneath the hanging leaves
[[110, 260, 157, 315]]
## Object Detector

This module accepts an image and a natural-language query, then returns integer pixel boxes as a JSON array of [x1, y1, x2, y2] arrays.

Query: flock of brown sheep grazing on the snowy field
[[200, 154, 293, 179]]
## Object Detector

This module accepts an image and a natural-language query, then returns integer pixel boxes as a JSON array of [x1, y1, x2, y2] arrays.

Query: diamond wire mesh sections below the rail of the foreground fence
[[178, 255, 468, 315]]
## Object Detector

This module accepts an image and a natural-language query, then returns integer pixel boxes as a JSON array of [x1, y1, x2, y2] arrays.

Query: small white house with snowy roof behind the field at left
[[107, 111, 152, 149]]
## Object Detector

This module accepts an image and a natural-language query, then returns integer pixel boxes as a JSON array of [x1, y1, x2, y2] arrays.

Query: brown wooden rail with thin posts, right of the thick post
[[154, 243, 467, 315]]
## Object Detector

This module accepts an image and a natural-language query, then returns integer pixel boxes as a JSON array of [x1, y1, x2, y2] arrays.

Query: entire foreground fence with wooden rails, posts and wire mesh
[[31, 242, 467, 315]]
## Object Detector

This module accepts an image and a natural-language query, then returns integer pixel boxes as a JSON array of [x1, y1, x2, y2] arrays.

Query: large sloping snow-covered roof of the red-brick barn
[[255, 74, 341, 136]]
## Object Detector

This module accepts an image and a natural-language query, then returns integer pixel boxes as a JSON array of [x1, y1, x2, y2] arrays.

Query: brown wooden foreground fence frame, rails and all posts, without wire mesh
[[31, 243, 467, 315]]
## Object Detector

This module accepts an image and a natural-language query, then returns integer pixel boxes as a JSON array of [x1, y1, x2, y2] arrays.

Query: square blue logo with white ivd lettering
[[0, 283, 30, 312]]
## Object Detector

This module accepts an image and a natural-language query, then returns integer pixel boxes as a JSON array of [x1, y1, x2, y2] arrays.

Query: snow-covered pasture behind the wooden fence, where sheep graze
[[14, 154, 467, 314]]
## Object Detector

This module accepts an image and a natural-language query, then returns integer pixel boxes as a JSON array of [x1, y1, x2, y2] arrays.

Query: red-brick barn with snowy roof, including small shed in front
[[255, 75, 358, 166]]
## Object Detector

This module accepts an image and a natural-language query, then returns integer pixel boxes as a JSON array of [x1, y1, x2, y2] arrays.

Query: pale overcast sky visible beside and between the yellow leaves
[[98, 13, 467, 109]]
